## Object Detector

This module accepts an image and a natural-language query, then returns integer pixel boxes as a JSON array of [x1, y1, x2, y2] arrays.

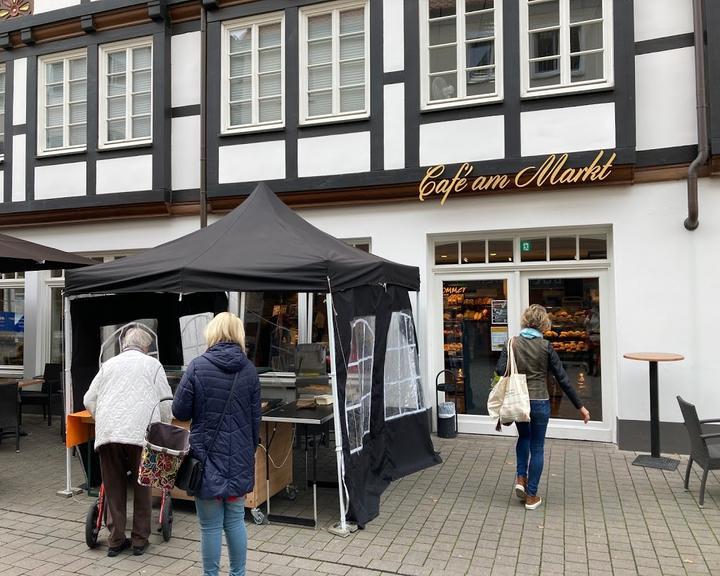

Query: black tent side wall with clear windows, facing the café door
[[333, 286, 440, 527]]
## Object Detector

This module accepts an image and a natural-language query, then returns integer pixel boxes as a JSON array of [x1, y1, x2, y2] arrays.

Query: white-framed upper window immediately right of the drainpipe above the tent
[[222, 13, 285, 133]]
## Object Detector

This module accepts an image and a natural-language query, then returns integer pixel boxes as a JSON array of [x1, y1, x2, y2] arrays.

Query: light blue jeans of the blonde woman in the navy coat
[[195, 498, 247, 576]]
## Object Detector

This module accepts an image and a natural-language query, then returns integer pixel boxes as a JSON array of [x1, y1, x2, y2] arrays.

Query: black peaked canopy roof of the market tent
[[65, 183, 420, 295]]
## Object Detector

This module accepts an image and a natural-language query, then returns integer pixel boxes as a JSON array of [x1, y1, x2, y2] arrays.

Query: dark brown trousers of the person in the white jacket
[[98, 443, 152, 548]]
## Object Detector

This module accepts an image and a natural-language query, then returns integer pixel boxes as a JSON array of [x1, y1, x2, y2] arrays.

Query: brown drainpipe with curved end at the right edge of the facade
[[685, 0, 710, 230]]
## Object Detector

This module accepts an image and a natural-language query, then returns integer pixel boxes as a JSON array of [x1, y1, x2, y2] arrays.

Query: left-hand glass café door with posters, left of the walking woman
[[439, 274, 518, 432]]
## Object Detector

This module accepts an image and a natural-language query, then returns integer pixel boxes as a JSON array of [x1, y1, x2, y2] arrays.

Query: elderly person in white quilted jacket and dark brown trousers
[[83, 327, 172, 557]]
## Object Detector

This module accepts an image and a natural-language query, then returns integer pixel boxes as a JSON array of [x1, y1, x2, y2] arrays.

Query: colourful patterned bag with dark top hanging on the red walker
[[138, 422, 190, 490]]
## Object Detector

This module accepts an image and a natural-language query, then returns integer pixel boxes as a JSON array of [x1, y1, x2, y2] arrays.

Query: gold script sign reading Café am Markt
[[418, 150, 617, 204]]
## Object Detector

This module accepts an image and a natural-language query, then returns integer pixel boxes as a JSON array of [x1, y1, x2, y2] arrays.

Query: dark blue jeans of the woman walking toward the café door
[[515, 400, 550, 496]]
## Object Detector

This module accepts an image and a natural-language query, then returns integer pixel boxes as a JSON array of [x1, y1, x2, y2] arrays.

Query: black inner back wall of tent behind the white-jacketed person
[[70, 292, 228, 412]]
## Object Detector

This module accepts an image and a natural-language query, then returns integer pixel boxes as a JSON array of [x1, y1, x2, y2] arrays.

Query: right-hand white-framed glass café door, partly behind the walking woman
[[521, 270, 615, 441]]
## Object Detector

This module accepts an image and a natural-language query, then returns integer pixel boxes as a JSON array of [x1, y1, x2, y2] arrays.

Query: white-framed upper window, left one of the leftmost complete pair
[[38, 50, 87, 154]]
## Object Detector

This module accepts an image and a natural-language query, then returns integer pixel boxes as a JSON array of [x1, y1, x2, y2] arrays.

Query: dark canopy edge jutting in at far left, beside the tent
[[0, 234, 95, 272]]
